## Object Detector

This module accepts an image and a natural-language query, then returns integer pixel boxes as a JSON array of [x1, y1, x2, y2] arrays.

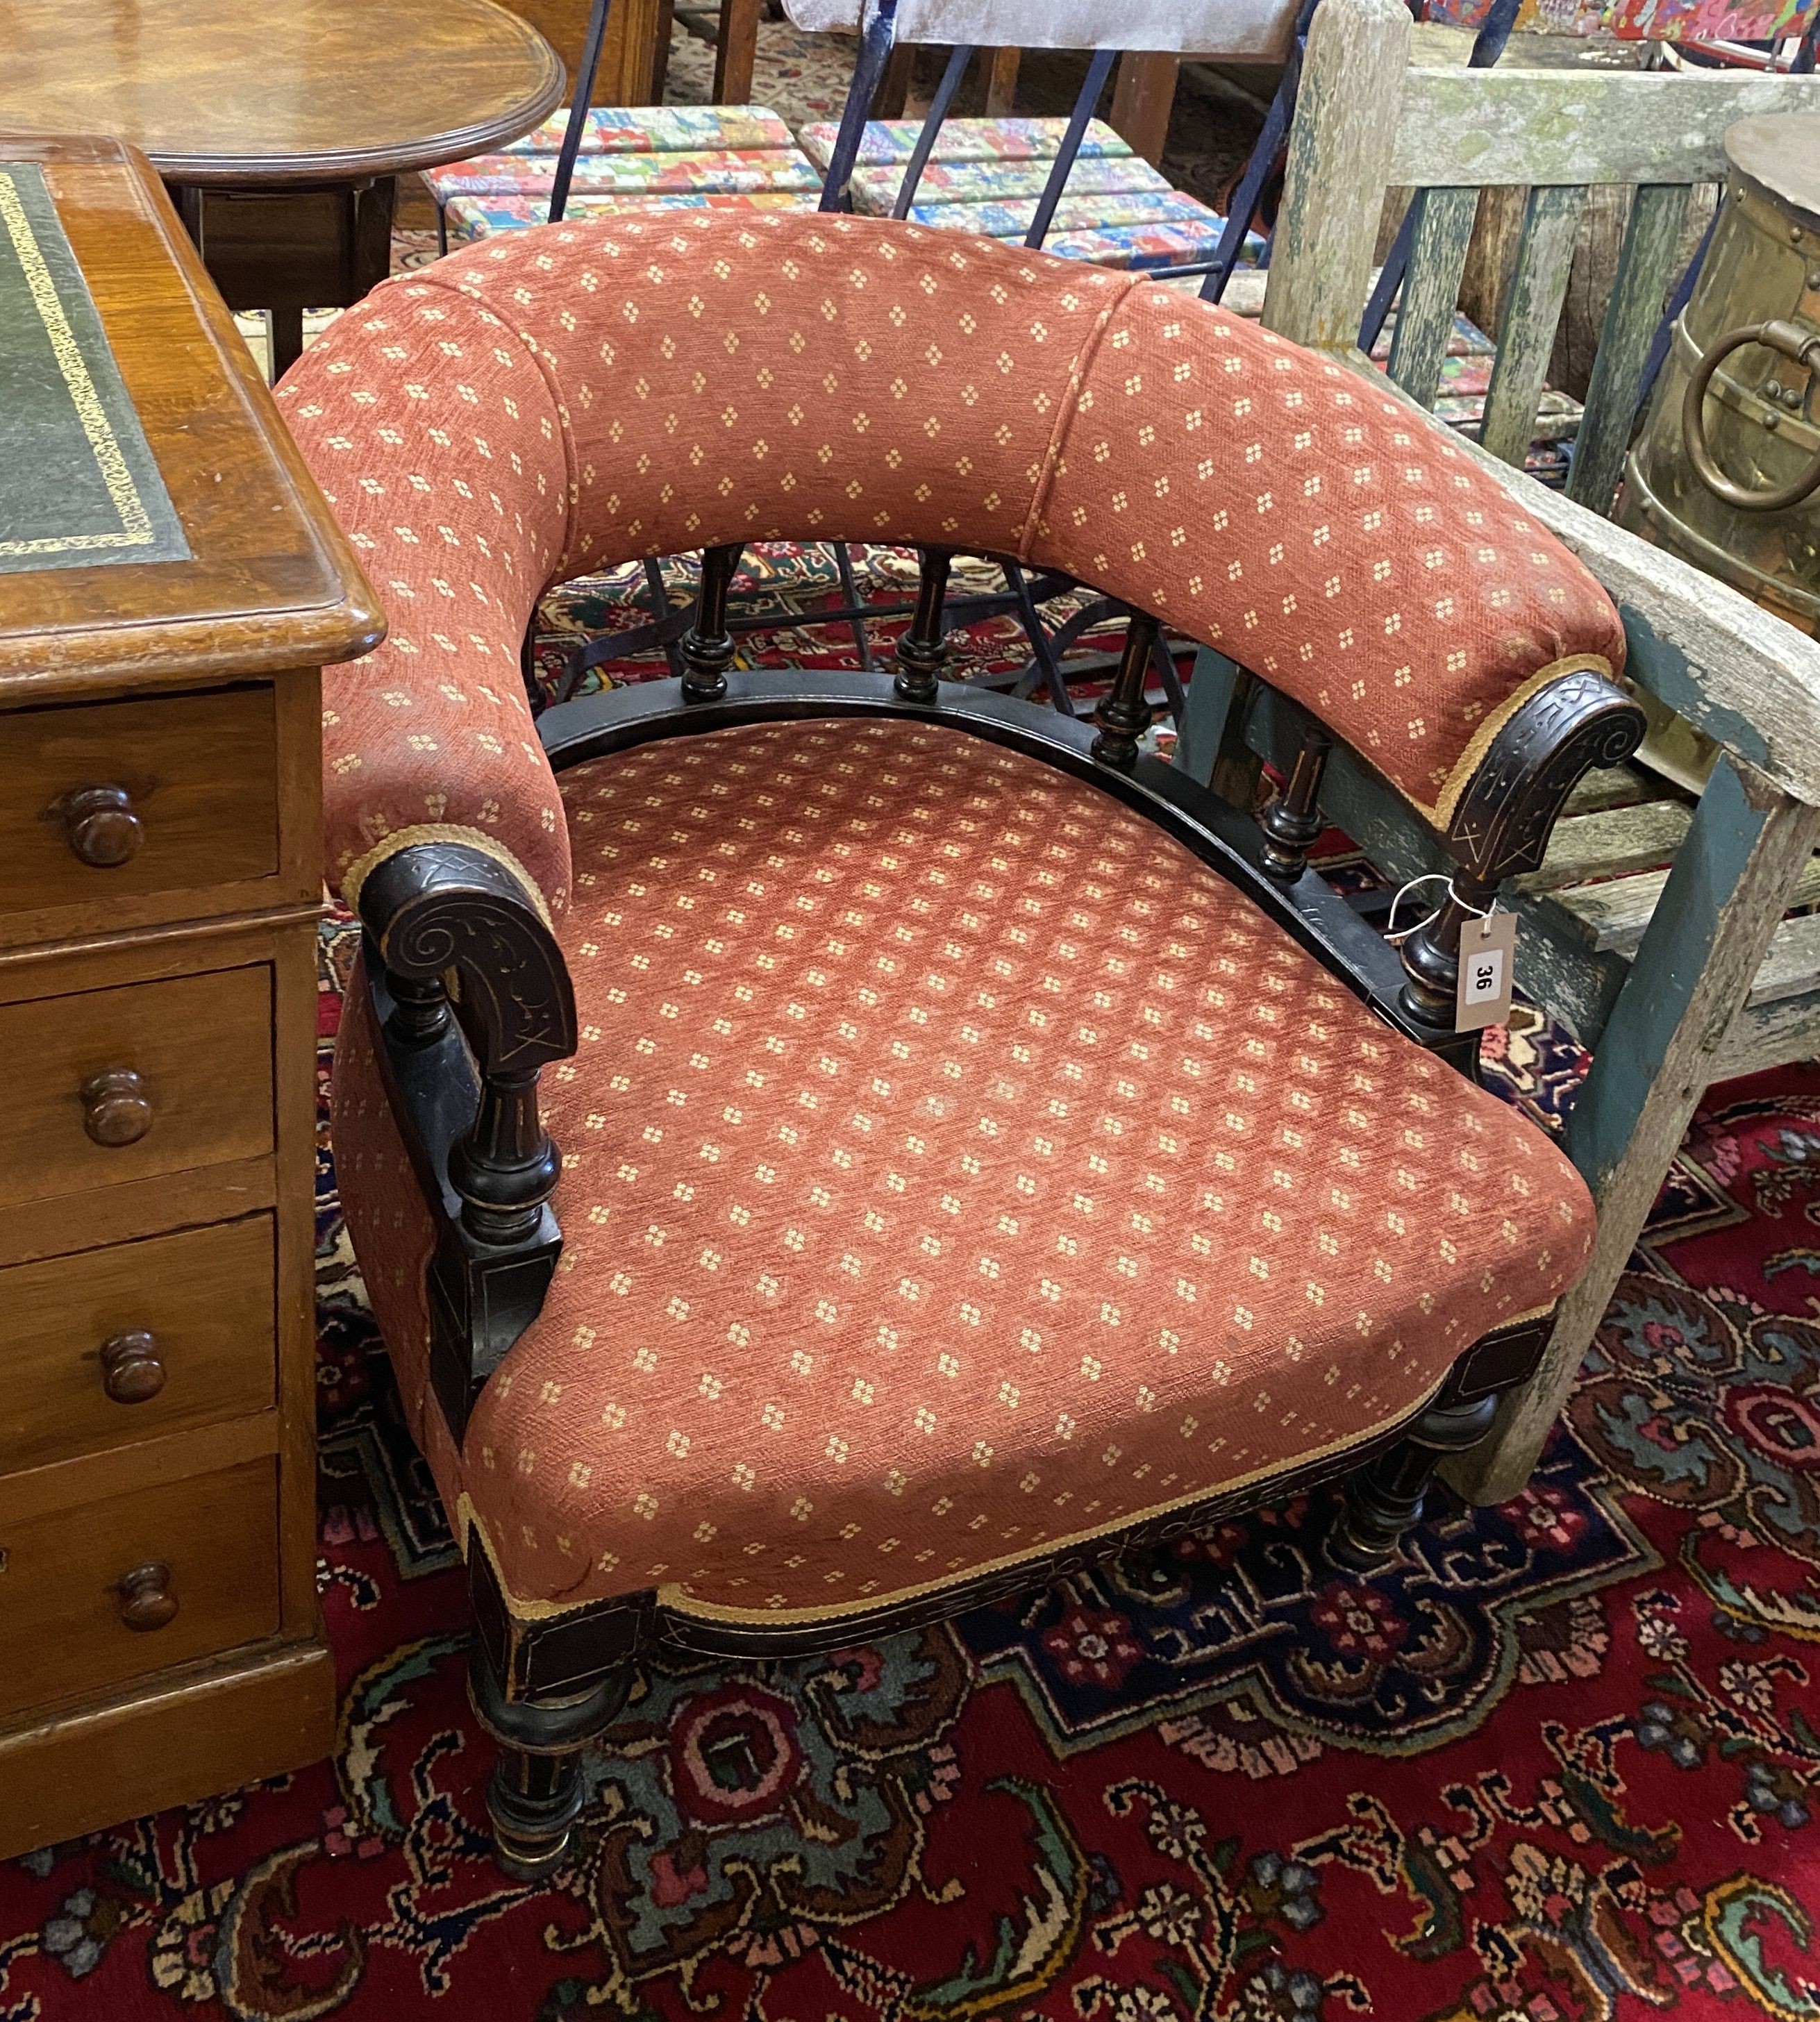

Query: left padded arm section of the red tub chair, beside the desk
[[279, 283, 568, 910]]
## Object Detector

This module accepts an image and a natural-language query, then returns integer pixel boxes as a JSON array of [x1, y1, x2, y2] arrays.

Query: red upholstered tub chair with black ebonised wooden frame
[[281, 212, 1642, 1876]]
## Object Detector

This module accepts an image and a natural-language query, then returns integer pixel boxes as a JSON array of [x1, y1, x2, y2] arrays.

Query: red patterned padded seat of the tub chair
[[335, 720, 1592, 1618]]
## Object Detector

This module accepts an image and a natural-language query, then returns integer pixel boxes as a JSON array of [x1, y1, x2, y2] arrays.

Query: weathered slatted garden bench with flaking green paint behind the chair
[[1179, 0, 1820, 1503]]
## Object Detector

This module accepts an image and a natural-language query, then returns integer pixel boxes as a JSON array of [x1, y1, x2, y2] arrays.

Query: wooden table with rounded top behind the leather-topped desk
[[0, 0, 565, 374]]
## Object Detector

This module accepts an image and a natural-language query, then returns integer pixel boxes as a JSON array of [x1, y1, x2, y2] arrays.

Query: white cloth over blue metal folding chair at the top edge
[[785, 0, 1296, 60]]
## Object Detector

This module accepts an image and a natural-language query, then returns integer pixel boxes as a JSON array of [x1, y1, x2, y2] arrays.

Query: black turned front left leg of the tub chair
[[467, 1638, 631, 1882]]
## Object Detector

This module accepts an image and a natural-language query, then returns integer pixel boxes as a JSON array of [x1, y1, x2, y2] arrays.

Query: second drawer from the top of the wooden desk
[[0, 964, 273, 1207]]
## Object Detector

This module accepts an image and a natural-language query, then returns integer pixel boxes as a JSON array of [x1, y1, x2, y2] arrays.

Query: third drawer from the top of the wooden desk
[[0, 1215, 277, 1474]]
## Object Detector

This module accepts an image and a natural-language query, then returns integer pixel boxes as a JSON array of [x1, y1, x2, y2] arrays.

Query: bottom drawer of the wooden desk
[[0, 1458, 279, 1721]]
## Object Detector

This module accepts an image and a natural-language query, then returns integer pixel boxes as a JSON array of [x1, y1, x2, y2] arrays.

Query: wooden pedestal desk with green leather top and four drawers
[[0, 135, 384, 1856]]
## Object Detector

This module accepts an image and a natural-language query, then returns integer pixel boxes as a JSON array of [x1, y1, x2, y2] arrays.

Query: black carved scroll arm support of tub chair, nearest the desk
[[358, 841, 576, 1439]]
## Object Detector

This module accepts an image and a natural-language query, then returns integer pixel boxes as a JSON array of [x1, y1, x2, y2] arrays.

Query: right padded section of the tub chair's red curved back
[[1035, 287, 1624, 823]]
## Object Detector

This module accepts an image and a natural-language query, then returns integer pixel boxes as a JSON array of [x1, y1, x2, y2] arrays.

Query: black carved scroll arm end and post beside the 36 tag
[[1403, 671, 1644, 1049]]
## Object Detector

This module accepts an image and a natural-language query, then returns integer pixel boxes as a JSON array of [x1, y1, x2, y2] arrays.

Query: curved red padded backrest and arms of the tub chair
[[281, 210, 1622, 910]]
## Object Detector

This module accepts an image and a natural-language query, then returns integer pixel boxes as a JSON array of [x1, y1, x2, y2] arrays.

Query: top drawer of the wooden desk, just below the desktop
[[0, 687, 279, 926]]
